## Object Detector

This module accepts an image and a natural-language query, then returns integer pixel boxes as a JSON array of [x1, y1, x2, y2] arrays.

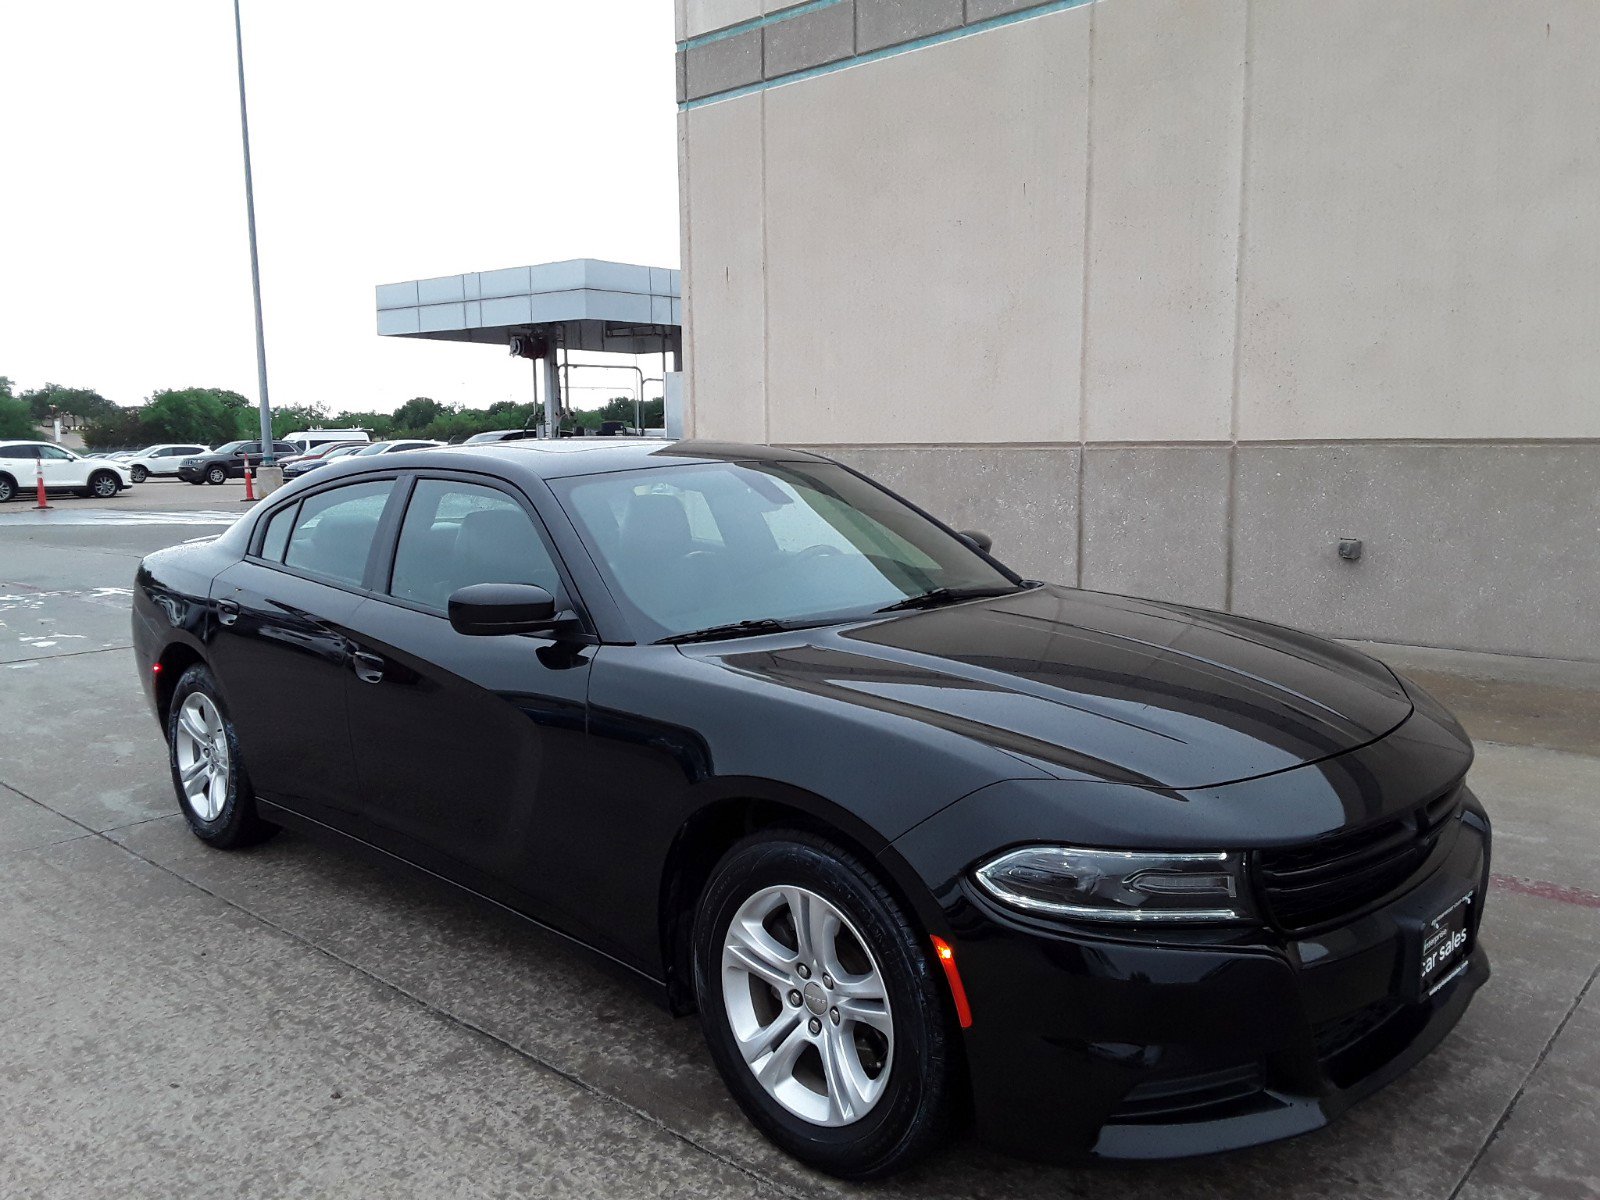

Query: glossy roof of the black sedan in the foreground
[[299, 437, 827, 478]]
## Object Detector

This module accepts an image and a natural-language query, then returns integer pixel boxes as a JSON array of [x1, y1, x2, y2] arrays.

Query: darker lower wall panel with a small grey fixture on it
[[1234, 443, 1600, 659]]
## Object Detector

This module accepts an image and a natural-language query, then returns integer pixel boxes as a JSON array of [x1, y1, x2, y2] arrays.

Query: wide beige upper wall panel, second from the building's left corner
[[761, 8, 1088, 443]]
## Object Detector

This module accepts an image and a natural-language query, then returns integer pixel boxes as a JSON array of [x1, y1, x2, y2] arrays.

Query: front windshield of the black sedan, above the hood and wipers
[[552, 462, 1016, 649]]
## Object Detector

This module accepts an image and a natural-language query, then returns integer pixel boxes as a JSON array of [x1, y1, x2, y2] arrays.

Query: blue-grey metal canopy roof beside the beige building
[[378, 258, 683, 354]]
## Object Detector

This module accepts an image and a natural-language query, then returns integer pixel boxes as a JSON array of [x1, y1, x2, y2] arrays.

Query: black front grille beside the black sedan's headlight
[[1256, 789, 1461, 931]]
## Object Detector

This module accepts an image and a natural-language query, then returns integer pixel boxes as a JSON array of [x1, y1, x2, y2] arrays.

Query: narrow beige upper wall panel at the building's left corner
[[678, 94, 766, 442]]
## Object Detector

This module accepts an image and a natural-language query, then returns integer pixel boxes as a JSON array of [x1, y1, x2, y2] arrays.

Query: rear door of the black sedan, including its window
[[210, 477, 395, 837]]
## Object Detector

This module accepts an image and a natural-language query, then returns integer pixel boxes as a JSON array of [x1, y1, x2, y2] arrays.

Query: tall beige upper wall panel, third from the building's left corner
[[1083, 0, 1245, 442]]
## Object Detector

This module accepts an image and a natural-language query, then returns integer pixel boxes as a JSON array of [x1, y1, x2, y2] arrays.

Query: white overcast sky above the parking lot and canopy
[[0, 0, 678, 408]]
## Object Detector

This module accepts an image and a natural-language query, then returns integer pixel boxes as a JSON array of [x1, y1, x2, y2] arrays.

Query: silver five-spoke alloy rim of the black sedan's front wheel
[[722, 886, 894, 1128]]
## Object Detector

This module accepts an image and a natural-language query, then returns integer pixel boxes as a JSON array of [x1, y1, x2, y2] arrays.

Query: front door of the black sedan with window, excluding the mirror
[[340, 475, 594, 917]]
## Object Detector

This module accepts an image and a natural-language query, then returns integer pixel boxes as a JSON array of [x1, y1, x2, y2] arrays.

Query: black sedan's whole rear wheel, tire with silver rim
[[166, 662, 278, 850]]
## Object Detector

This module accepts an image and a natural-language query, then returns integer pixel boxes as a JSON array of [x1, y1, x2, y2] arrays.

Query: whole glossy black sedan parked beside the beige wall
[[133, 438, 1490, 1178]]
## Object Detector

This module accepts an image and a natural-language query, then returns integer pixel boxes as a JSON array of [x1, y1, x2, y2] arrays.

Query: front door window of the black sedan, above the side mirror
[[389, 480, 560, 613]]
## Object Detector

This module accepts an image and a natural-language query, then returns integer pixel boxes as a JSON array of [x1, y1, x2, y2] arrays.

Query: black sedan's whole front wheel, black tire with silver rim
[[693, 830, 957, 1179]]
